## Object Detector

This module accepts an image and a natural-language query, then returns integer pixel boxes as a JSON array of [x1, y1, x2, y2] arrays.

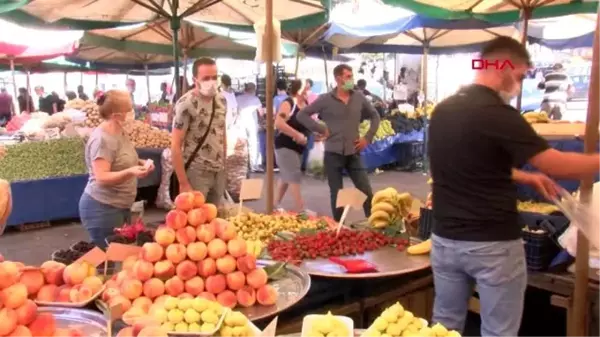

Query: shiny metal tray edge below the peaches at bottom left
[[38, 307, 108, 337]]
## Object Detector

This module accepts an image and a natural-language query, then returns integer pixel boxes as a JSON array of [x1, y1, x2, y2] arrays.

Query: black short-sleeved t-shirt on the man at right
[[428, 85, 549, 241]]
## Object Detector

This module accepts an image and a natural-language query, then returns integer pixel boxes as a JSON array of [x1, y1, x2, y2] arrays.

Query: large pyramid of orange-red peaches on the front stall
[[102, 192, 277, 320]]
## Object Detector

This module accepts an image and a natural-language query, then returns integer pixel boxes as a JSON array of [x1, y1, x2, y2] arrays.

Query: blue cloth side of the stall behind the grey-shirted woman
[[7, 149, 162, 226]]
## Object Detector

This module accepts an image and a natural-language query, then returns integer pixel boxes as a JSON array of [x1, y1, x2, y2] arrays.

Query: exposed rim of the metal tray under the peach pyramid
[[235, 260, 310, 321]]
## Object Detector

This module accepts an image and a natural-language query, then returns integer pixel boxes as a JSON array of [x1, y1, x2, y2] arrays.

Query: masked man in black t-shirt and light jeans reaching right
[[428, 37, 600, 337]]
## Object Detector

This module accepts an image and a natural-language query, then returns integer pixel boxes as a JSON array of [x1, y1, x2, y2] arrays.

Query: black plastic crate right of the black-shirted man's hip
[[523, 223, 560, 271]]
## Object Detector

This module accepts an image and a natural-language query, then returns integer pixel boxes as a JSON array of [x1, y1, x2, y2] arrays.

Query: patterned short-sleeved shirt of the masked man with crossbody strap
[[173, 90, 227, 172]]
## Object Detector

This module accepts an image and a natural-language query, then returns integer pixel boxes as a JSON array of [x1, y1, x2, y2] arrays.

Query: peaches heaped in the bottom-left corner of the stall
[[0, 261, 103, 337]]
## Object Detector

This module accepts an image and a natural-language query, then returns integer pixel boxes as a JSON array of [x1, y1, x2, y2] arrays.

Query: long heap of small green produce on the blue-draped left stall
[[0, 138, 87, 182]]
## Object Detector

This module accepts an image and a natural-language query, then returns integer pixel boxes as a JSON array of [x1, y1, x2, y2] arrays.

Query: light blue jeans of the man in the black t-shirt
[[431, 235, 527, 337]]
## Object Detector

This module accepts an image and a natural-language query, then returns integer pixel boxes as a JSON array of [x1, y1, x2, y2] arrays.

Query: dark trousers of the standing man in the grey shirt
[[324, 152, 373, 221]]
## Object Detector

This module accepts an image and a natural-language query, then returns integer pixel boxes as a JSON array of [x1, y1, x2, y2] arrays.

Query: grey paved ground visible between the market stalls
[[0, 171, 429, 265]]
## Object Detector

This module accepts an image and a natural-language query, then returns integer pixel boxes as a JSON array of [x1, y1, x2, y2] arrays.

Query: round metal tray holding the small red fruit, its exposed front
[[300, 247, 431, 279]]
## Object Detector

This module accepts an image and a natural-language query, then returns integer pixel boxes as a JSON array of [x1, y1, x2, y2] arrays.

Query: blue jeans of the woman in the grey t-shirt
[[79, 193, 131, 249]]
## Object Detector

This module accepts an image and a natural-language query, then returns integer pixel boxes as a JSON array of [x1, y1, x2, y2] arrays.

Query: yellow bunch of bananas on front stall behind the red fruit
[[369, 187, 413, 228]]
